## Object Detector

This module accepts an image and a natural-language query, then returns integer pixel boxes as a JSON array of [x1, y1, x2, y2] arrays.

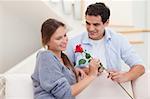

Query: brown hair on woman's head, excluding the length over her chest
[[41, 19, 65, 46]]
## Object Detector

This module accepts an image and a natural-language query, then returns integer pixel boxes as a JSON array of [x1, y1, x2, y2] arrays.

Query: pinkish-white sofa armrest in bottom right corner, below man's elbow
[[132, 71, 150, 99]]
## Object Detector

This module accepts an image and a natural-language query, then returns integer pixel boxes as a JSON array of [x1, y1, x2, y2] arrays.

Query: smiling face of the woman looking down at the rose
[[47, 26, 68, 52]]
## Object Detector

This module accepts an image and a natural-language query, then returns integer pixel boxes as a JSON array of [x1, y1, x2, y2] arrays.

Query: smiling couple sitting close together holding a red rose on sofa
[[32, 3, 145, 99]]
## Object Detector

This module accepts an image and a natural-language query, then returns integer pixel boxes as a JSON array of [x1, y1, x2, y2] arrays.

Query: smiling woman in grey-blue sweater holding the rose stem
[[32, 19, 99, 99]]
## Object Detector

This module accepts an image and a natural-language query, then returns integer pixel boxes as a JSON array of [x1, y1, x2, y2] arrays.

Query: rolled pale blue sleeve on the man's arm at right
[[121, 38, 143, 67]]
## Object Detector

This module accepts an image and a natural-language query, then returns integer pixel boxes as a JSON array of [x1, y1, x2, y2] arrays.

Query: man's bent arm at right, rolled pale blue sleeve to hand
[[110, 37, 145, 82]]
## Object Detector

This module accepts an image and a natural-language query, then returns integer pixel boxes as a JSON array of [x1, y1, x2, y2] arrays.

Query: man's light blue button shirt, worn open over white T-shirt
[[66, 29, 143, 70]]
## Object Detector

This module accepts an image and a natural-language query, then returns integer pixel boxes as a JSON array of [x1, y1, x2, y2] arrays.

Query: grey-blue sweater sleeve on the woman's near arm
[[38, 53, 72, 99]]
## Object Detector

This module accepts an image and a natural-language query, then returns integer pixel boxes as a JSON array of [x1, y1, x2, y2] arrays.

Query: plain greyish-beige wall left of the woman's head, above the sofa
[[0, 0, 63, 73]]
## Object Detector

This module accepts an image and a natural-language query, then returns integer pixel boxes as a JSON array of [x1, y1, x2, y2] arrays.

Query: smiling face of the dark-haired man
[[85, 15, 108, 40]]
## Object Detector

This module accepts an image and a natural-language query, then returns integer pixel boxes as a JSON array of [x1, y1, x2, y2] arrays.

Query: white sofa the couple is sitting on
[[0, 50, 150, 99]]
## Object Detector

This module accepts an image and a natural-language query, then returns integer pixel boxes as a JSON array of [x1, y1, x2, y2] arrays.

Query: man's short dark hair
[[85, 2, 110, 23]]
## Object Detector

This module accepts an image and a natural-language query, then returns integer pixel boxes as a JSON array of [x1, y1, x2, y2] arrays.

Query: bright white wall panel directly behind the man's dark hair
[[83, 0, 133, 26]]
